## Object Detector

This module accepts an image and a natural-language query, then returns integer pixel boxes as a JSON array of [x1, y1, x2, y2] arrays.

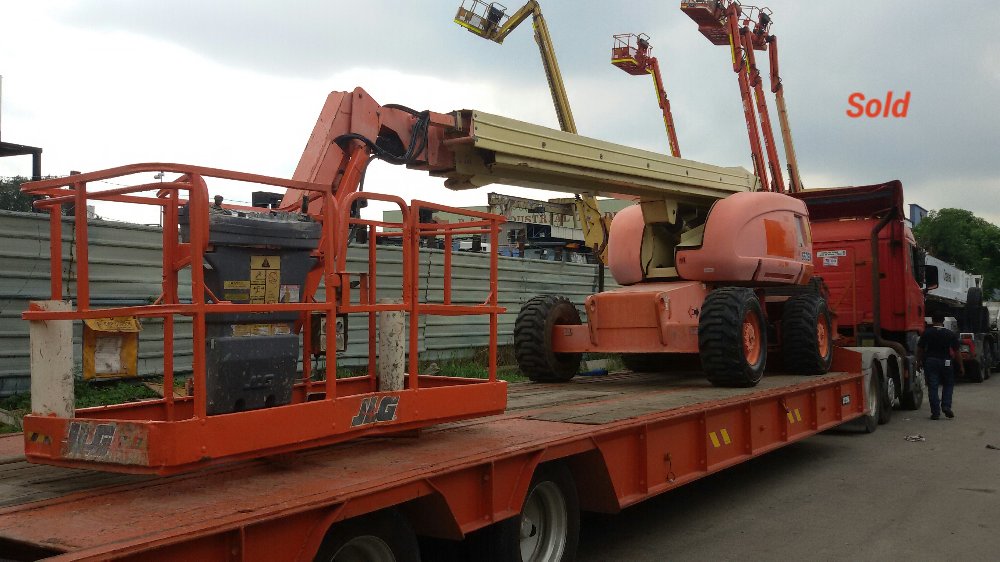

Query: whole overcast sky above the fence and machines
[[0, 0, 1000, 222]]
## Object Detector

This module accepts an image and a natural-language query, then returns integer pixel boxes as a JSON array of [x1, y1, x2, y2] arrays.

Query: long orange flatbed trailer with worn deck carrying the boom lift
[[0, 349, 872, 561]]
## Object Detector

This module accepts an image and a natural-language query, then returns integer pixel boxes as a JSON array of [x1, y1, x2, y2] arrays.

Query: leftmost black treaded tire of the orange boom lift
[[514, 295, 583, 382]]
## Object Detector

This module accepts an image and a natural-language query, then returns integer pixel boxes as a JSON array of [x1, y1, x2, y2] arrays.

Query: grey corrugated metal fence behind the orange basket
[[0, 211, 615, 396]]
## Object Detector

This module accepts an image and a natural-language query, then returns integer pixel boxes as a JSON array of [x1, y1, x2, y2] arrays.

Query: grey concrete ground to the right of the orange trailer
[[578, 375, 1000, 562]]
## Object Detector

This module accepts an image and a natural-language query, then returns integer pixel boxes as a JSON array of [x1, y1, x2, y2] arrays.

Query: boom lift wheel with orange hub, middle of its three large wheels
[[698, 287, 767, 387]]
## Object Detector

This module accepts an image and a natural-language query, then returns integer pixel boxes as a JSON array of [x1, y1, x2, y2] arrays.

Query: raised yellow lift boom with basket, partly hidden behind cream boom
[[455, 0, 609, 263]]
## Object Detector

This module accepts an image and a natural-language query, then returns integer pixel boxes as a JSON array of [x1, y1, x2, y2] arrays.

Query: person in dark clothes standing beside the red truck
[[917, 314, 965, 420]]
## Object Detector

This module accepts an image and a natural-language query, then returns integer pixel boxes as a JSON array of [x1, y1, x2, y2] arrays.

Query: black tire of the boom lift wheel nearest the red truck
[[781, 294, 833, 375]]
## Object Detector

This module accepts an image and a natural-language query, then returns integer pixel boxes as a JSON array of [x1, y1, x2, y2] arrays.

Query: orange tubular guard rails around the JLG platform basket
[[23, 163, 504, 421]]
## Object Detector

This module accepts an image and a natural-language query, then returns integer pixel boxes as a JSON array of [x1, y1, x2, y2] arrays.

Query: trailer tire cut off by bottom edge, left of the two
[[315, 509, 420, 562]]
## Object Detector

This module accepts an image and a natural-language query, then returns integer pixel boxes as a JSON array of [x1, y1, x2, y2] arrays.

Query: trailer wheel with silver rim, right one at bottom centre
[[466, 464, 580, 562]]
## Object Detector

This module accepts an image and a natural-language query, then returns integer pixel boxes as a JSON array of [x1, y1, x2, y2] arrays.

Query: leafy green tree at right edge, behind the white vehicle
[[913, 209, 1000, 295]]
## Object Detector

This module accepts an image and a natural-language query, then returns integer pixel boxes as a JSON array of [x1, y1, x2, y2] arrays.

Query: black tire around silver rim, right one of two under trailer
[[465, 463, 580, 562]]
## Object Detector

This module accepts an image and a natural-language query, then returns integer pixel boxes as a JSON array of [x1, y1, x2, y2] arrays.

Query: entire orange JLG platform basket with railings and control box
[[23, 163, 506, 474]]
